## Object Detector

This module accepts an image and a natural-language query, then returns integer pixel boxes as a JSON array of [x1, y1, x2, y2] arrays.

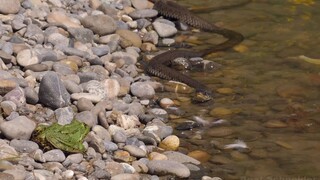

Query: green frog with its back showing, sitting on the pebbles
[[31, 120, 90, 153]]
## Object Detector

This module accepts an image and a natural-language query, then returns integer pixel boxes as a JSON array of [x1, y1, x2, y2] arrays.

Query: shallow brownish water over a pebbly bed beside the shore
[[162, 0, 320, 179]]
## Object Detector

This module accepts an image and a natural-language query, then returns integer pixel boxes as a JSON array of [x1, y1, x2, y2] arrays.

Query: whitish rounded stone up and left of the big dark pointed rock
[[17, 49, 40, 67]]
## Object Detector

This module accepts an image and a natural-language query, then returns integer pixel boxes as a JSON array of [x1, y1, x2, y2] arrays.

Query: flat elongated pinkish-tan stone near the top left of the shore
[[47, 11, 81, 28]]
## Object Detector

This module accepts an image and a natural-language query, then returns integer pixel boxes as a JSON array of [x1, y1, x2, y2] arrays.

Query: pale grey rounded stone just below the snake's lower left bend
[[130, 82, 155, 99]]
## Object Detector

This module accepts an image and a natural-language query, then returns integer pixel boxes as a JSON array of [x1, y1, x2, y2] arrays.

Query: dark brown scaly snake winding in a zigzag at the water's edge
[[145, 0, 248, 102]]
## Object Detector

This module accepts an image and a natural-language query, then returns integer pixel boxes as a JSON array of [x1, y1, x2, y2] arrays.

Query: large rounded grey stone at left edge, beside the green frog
[[0, 116, 36, 140]]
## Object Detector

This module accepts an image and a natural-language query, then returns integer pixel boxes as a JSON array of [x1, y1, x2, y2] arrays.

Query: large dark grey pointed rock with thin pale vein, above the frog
[[39, 71, 70, 109]]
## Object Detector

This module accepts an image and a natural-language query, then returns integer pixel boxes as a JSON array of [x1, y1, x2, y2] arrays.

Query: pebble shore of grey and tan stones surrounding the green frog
[[0, 0, 219, 180]]
